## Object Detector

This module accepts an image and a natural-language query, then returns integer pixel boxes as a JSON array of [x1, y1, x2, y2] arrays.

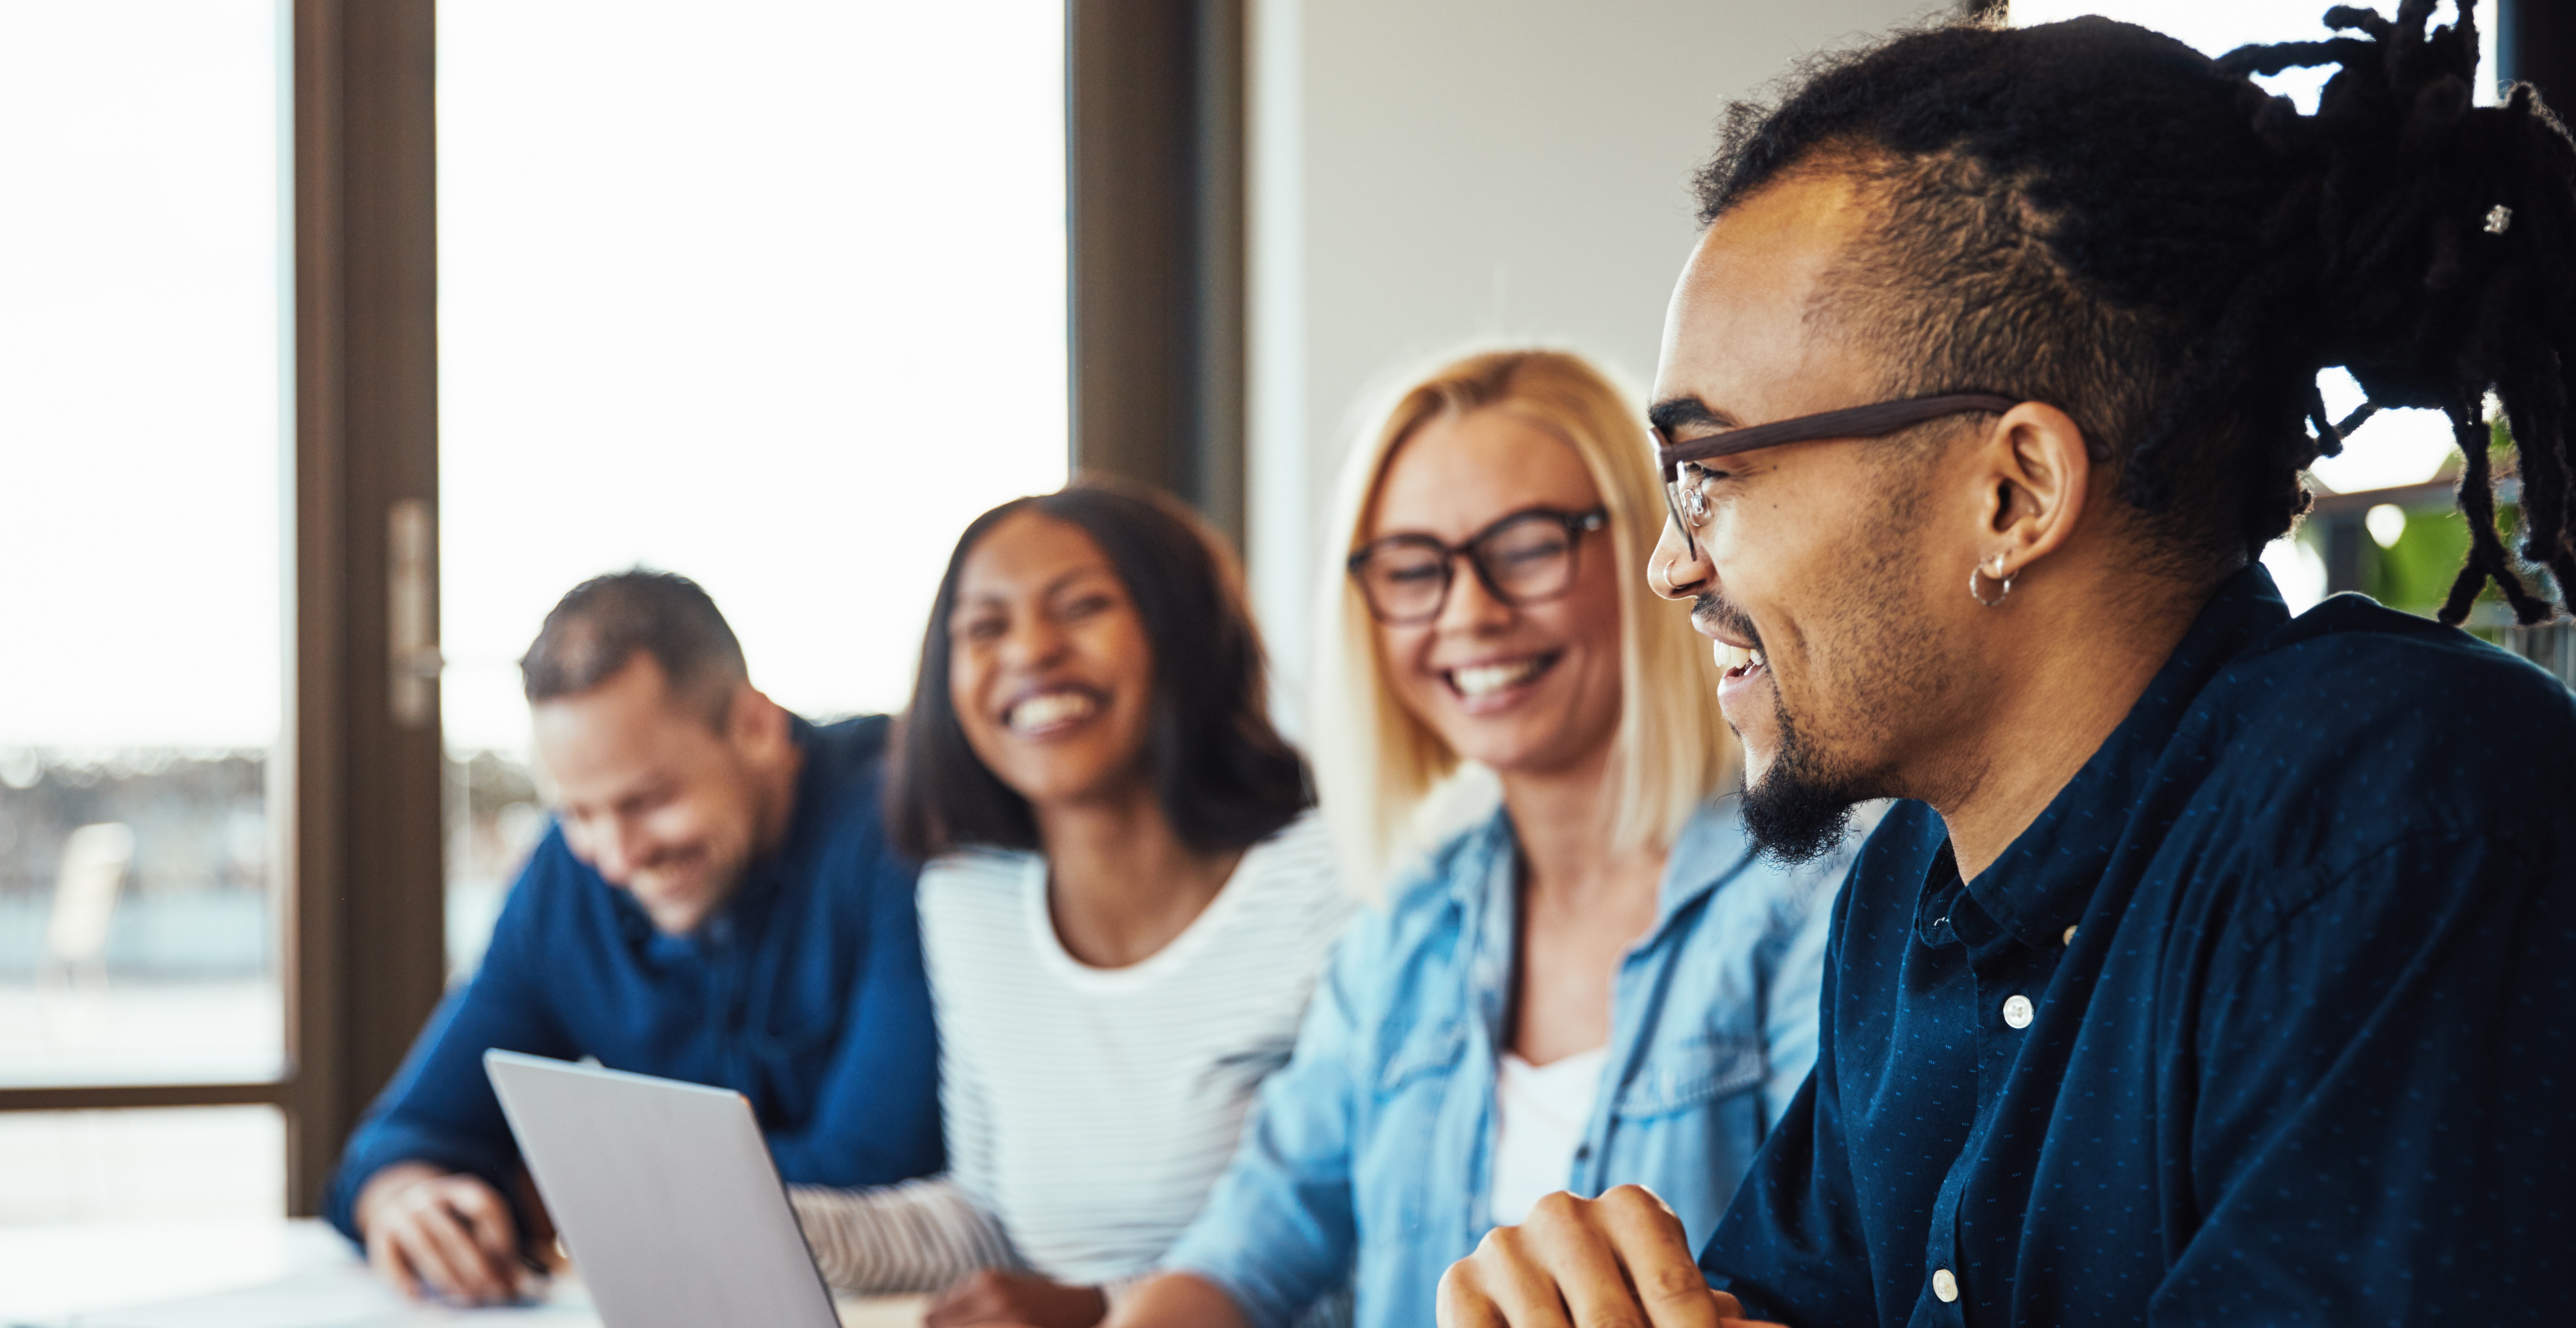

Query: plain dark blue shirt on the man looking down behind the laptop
[[324, 717, 943, 1238]]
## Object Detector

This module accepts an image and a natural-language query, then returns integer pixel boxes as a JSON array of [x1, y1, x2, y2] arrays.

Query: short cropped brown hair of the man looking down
[[518, 567, 749, 730]]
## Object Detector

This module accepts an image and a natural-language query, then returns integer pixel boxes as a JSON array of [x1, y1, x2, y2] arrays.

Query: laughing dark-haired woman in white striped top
[[796, 485, 1355, 1325]]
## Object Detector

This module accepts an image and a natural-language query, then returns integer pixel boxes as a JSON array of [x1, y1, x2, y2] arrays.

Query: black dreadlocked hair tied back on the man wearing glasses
[[1697, 0, 2576, 624]]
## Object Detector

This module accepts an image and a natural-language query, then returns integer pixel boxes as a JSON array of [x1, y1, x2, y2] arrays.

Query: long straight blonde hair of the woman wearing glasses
[[1314, 351, 1736, 885]]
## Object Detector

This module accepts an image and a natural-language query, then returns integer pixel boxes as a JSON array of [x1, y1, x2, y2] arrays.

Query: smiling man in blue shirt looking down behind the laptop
[[313, 567, 943, 1302]]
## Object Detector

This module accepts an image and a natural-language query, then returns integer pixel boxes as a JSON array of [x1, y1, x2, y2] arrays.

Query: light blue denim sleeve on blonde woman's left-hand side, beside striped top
[[1162, 913, 1386, 1328]]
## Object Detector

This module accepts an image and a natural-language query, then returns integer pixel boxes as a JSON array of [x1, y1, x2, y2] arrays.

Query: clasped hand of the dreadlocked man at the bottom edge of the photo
[[1440, 1186, 1778, 1328]]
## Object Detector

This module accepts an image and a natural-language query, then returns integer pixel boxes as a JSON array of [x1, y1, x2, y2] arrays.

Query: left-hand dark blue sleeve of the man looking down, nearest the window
[[322, 830, 579, 1240]]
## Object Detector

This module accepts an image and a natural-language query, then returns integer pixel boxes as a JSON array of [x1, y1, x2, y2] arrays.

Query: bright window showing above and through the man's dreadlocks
[[2012, 0, 2496, 611]]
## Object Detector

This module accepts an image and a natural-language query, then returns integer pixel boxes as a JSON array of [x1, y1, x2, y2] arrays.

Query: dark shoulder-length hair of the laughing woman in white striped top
[[886, 479, 1314, 859]]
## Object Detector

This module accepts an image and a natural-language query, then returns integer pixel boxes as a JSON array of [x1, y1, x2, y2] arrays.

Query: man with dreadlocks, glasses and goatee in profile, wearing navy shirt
[[1440, 0, 2576, 1328]]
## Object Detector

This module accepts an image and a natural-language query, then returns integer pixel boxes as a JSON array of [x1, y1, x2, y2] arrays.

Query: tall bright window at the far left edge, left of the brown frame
[[0, 0, 288, 1225]]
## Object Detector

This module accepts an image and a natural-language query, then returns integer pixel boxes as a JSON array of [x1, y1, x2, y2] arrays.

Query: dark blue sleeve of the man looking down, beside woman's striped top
[[770, 836, 948, 1186]]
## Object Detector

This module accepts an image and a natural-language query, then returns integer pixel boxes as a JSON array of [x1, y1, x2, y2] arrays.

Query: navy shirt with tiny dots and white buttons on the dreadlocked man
[[1700, 567, 2576, 1328]]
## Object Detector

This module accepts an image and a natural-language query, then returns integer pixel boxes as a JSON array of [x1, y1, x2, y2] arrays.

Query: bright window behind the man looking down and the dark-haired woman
[[438, 0, 1066, 970]]
